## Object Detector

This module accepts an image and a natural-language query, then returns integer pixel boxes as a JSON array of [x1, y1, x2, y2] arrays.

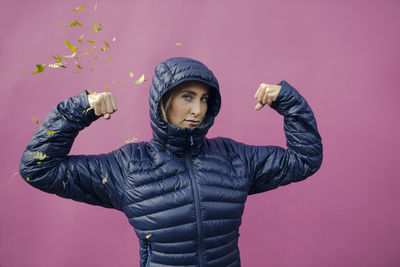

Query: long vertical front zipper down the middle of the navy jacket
[[185, 151, 204, 267]]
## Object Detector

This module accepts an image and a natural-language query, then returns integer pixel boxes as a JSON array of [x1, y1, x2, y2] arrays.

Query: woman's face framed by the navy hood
[[167, 82, 208, 128]]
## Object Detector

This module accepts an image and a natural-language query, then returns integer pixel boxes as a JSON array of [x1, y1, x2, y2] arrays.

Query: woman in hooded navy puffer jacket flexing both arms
[[20, 57, 322, 266]]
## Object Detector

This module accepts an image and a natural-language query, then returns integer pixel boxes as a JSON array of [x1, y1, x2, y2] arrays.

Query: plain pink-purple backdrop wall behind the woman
[[0, 0, 400, 267]]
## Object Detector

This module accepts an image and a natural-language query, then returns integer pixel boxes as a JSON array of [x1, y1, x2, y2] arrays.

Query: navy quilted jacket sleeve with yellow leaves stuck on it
[[20, 91, 132, 210]]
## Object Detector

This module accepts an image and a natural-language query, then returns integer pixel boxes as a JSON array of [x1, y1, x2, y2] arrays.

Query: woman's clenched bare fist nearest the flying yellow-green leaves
[[88, 92, 117, 120]]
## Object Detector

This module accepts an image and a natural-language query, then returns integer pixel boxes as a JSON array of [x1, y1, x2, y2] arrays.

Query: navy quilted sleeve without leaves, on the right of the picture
[[246, 80, 322, 194]]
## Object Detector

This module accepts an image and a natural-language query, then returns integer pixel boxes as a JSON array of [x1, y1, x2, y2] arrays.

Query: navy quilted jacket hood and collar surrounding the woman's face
[[149, 57, 221, 156]]
